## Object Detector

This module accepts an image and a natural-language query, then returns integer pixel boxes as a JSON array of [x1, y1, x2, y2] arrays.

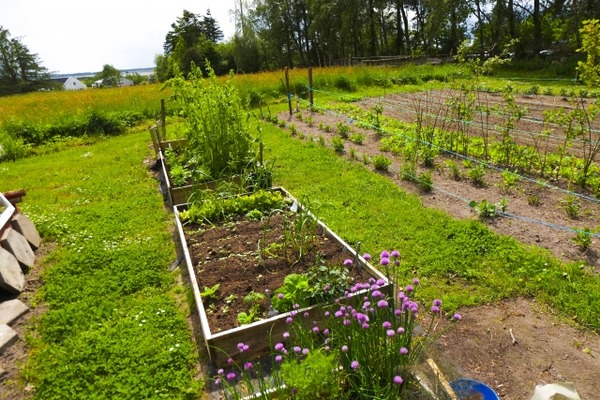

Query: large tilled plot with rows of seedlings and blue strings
[[279, 93, 600, 272]]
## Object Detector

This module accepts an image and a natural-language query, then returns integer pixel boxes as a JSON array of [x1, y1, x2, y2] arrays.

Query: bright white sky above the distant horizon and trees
[[0, 0, 236, 74]]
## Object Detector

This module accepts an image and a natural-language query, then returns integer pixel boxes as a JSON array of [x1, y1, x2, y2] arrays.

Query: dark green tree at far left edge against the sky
[[0, 26, 50, 96]]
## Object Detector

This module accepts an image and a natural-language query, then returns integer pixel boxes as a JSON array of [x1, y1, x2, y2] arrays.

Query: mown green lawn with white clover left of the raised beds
[[0, 129, 201, 399]]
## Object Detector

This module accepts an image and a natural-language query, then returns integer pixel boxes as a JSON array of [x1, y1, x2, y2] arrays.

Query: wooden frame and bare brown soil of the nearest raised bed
[[175, 188, 391, 365]]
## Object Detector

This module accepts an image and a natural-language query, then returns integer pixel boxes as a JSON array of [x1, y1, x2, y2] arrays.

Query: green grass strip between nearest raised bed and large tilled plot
[[263, 118, 600, 330]]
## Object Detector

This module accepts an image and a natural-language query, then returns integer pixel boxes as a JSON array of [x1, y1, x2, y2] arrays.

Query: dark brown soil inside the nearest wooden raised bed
[[184, 212, 370, 333]]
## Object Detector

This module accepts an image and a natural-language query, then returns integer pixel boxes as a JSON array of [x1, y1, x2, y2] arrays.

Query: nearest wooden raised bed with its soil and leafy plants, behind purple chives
[[175, 189, 389, 364]]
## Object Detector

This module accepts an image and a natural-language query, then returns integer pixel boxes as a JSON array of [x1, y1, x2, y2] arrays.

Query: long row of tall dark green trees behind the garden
[[156, 0, 600, 79]]
